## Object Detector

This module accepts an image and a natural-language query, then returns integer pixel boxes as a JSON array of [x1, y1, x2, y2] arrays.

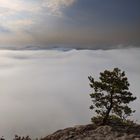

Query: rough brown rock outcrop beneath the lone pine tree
[[41, 124, 140, 140]]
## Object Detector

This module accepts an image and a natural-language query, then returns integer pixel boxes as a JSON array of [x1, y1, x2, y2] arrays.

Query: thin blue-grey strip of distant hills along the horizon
[[0, 44, 140, 51]]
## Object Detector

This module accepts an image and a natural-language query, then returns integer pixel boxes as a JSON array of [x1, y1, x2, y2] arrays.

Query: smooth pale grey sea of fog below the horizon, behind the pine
[[0, 48, 140, 138]]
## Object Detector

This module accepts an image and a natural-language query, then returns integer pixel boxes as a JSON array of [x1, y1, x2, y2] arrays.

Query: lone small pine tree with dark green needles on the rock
[[88, 68, 136, 125]]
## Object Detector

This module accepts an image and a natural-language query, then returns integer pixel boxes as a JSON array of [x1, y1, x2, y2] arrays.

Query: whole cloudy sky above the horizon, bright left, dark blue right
[[0, 0, 140, 49]]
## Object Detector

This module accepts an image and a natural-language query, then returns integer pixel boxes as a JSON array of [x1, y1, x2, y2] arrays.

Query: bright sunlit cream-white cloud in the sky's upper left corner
[[0, 0, 74, 30]]
